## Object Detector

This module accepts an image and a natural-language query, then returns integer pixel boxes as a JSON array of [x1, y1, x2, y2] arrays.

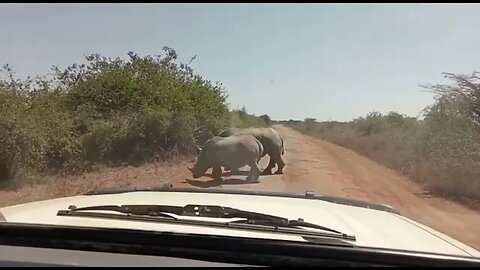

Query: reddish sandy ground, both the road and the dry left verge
[[0, 125, 480, 249]]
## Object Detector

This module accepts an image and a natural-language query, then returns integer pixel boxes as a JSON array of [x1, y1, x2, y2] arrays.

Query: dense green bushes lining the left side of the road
[[0, 47, 270, 184]]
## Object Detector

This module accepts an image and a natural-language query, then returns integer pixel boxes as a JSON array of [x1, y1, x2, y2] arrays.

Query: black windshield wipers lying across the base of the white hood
[[58, 204, 356, 241]]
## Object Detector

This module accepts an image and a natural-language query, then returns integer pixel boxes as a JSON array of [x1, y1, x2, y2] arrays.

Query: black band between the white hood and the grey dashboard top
[[0, 222, 480, 267]]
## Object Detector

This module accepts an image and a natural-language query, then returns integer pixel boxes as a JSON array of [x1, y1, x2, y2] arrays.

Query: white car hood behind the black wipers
[[0, 191, 480, 257]]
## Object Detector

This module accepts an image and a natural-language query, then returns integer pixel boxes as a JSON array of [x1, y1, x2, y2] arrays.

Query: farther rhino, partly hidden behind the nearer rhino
[[219, 127, 285, 174]]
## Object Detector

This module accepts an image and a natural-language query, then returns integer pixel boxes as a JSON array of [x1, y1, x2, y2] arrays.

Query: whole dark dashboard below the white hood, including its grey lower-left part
[[0, 222, 480, 267]]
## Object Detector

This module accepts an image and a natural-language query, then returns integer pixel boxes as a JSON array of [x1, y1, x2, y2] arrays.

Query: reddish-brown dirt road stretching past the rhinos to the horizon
[[173, 126, 480, 249]]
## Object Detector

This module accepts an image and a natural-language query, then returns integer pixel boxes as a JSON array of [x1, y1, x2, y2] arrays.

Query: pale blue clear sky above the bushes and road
[[0, 4, 480, 121]]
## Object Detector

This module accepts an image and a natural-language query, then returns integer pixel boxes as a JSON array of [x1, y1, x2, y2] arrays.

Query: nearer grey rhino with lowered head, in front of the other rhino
[[188, 135, 264, 182]]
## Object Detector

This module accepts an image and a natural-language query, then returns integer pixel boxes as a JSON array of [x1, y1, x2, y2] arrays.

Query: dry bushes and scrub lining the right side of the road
[[282, 73, 480, 203]]
